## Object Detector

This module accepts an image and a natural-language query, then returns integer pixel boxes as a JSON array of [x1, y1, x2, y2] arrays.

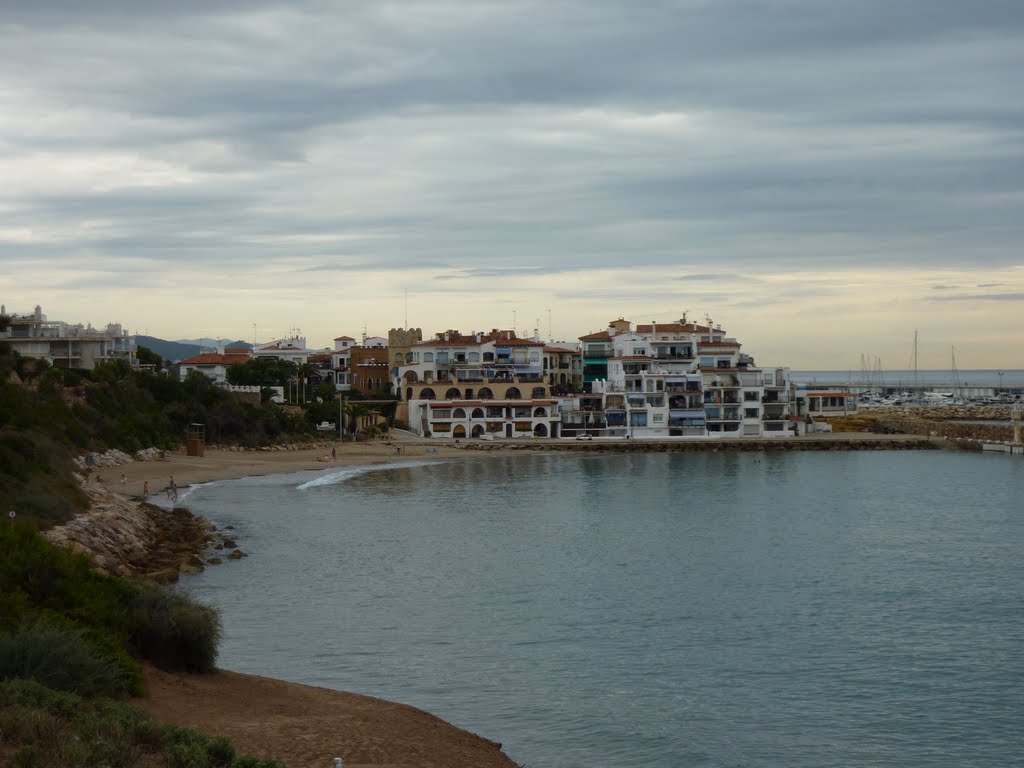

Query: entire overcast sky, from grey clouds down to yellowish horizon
[[0, 0, 1024, 370]]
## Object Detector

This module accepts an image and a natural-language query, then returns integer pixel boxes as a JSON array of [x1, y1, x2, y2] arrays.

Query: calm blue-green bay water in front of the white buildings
[[185, 452, 1024, 768]]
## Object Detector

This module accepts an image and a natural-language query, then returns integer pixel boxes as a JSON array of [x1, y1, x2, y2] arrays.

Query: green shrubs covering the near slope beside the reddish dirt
[[0, 521, 279, 768]]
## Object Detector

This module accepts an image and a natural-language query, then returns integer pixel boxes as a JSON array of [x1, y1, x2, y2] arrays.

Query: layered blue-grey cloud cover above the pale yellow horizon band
[[0, 0, 1024, 300]]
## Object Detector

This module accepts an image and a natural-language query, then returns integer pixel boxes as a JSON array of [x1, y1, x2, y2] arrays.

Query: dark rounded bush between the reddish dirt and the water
[[132, 589, 222, 672]]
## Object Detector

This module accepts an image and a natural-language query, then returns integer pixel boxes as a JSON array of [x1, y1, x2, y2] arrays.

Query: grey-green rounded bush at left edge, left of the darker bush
[[0, 618, 130, 696]]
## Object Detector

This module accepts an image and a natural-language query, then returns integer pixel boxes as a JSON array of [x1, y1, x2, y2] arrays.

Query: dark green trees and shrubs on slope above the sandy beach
[[0, 343, 314, 525]]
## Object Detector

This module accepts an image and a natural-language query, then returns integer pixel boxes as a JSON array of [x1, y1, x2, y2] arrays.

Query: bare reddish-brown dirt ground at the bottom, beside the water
[[133, 668, 515, 768]]
